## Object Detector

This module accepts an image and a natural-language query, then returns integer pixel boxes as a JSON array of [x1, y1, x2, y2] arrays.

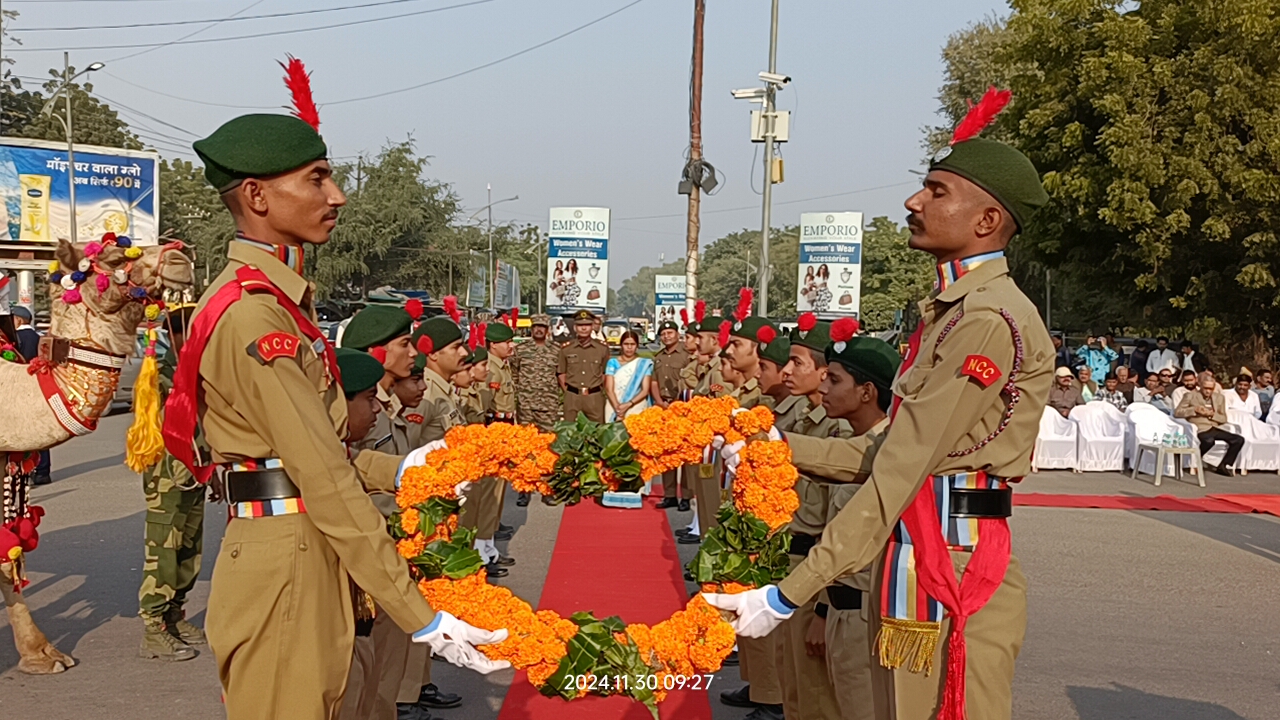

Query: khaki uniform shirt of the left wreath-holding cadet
[[196, 242, 435, 632]]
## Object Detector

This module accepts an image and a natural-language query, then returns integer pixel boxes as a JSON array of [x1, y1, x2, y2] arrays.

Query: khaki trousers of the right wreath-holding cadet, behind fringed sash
[[868, 552, 1027, 720]]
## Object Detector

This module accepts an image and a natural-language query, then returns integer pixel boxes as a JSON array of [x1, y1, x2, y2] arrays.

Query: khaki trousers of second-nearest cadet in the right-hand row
[[773, 555, 844, 720]]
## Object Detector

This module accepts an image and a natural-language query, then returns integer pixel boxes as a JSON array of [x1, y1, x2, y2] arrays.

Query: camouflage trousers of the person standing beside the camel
[[138, 454, 205, 618]]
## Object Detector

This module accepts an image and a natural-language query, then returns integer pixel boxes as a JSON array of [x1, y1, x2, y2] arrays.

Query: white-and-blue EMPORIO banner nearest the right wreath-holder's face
[[796, 213, 863, 318]]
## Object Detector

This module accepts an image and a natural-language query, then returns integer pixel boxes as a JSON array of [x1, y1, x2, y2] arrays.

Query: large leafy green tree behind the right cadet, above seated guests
[[942, 0, 1280, 366]]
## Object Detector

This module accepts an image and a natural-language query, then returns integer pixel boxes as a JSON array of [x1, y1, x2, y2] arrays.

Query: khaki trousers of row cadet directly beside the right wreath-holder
[[827, 593, 875, 720]]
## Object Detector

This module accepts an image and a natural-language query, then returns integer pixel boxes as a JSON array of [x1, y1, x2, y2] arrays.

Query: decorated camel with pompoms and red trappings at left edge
[[0, 234, 192, 675]]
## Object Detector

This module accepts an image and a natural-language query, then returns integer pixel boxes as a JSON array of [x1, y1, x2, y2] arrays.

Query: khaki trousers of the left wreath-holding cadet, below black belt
[[205, 515, 356, 720]]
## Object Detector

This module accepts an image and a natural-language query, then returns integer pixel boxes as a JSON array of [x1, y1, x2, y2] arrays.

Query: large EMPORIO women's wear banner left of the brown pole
[[547, 208, 609, 313]]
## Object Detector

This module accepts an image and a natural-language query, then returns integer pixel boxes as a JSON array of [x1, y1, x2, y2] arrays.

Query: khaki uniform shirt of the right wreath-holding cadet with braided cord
[[778, 258, 1055, 603]]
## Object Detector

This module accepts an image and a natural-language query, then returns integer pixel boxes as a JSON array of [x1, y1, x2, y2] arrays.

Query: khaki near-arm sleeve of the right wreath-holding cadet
[[778, 310, 1014, 605]]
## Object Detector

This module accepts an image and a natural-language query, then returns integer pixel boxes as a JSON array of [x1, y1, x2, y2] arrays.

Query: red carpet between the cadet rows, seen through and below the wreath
[[498, 501, 714, 720]]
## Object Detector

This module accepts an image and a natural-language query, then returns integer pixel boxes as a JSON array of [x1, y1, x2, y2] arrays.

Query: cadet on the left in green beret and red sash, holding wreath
[[164, 115, 506, 720]]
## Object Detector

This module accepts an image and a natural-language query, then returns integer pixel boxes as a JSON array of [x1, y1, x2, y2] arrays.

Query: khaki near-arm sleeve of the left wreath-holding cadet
[[201, 305, 435, 633]]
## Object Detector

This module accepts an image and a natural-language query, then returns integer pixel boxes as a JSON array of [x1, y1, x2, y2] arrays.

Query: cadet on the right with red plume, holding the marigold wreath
[[708, 102, 1055, 720]]
